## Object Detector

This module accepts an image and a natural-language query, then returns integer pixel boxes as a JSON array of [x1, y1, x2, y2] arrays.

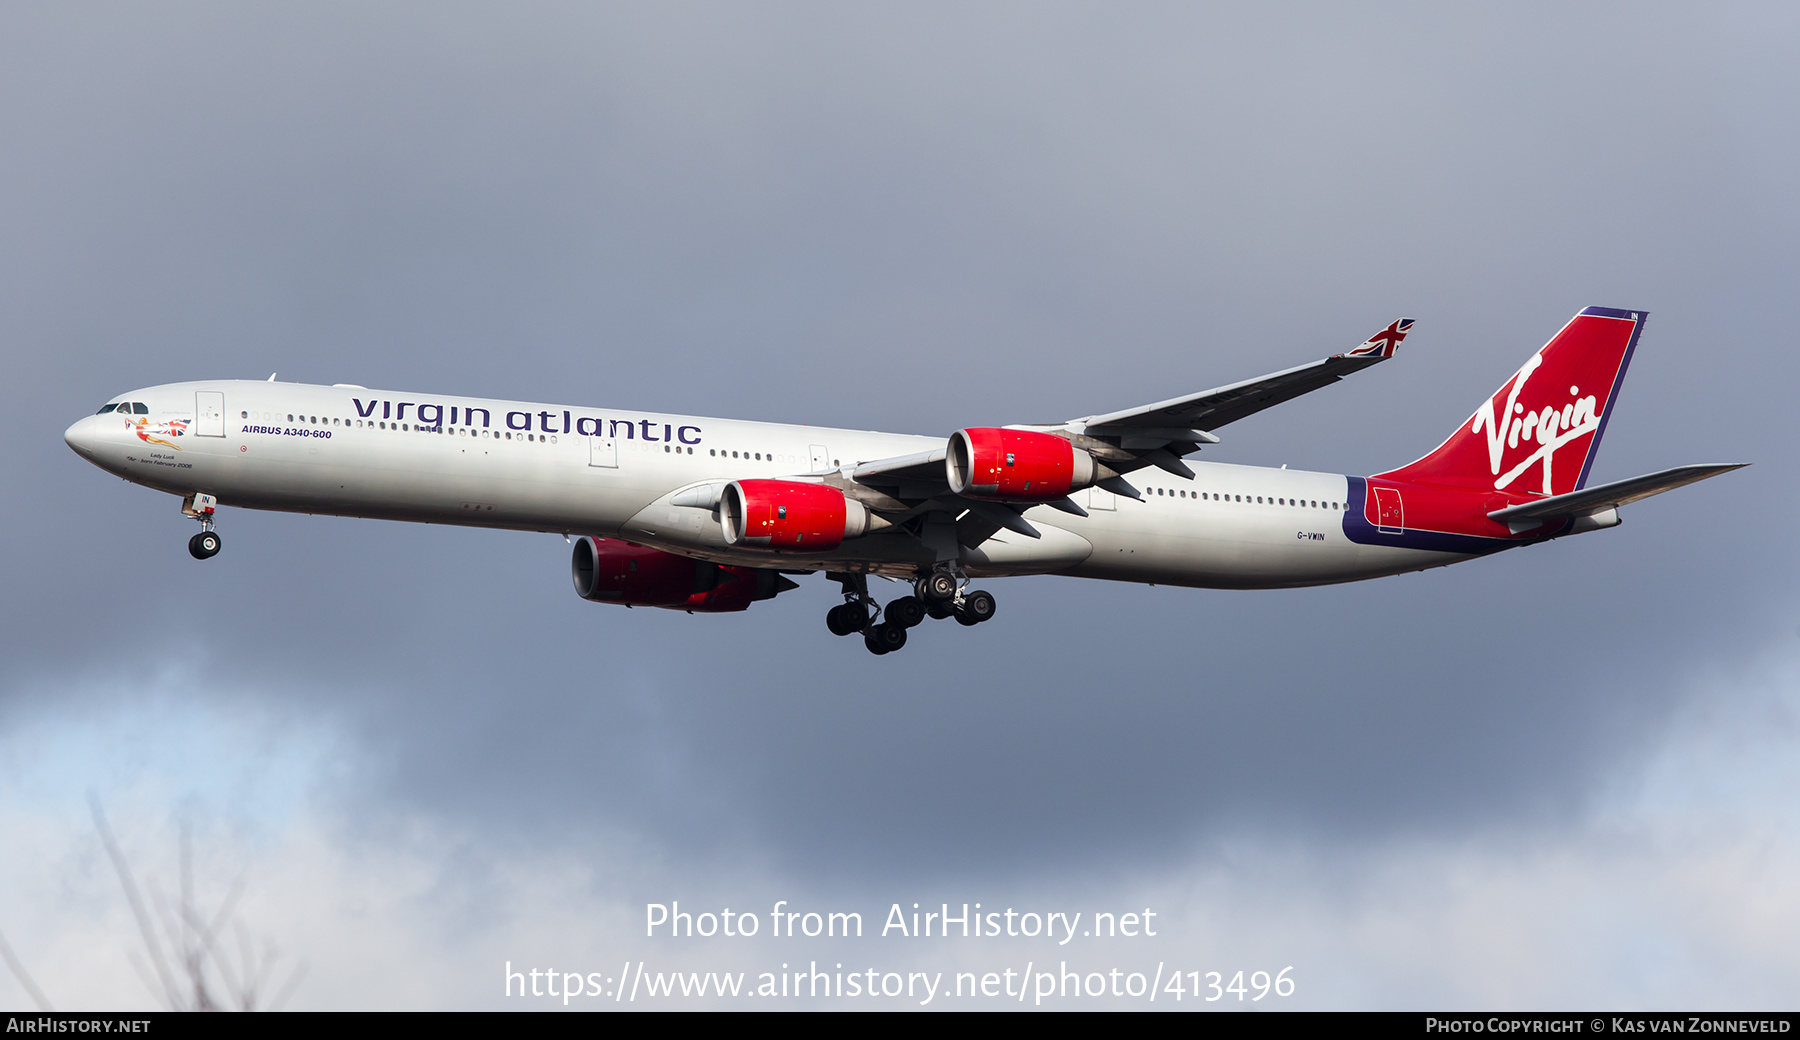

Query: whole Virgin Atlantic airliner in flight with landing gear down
[[63, 308, 1741, 655]]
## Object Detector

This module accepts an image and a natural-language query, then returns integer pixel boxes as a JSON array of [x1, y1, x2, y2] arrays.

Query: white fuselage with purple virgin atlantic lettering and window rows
[[65, 381, 1467, 588]]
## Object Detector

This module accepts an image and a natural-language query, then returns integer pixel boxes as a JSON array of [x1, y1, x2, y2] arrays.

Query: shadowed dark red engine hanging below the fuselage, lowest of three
[[569, 538, 797, 614]]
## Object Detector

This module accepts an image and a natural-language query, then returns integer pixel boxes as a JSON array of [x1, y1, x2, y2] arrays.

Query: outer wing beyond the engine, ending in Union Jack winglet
[[1069, 318, 1413, 433]]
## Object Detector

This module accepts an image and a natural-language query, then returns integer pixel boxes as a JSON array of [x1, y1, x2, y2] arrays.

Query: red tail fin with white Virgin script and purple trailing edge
[[1379, 308, 1647, 495]]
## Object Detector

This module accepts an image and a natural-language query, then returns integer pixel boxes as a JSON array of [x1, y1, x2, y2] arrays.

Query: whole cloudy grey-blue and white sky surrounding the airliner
[[0, 0, 1800, 1009]]
